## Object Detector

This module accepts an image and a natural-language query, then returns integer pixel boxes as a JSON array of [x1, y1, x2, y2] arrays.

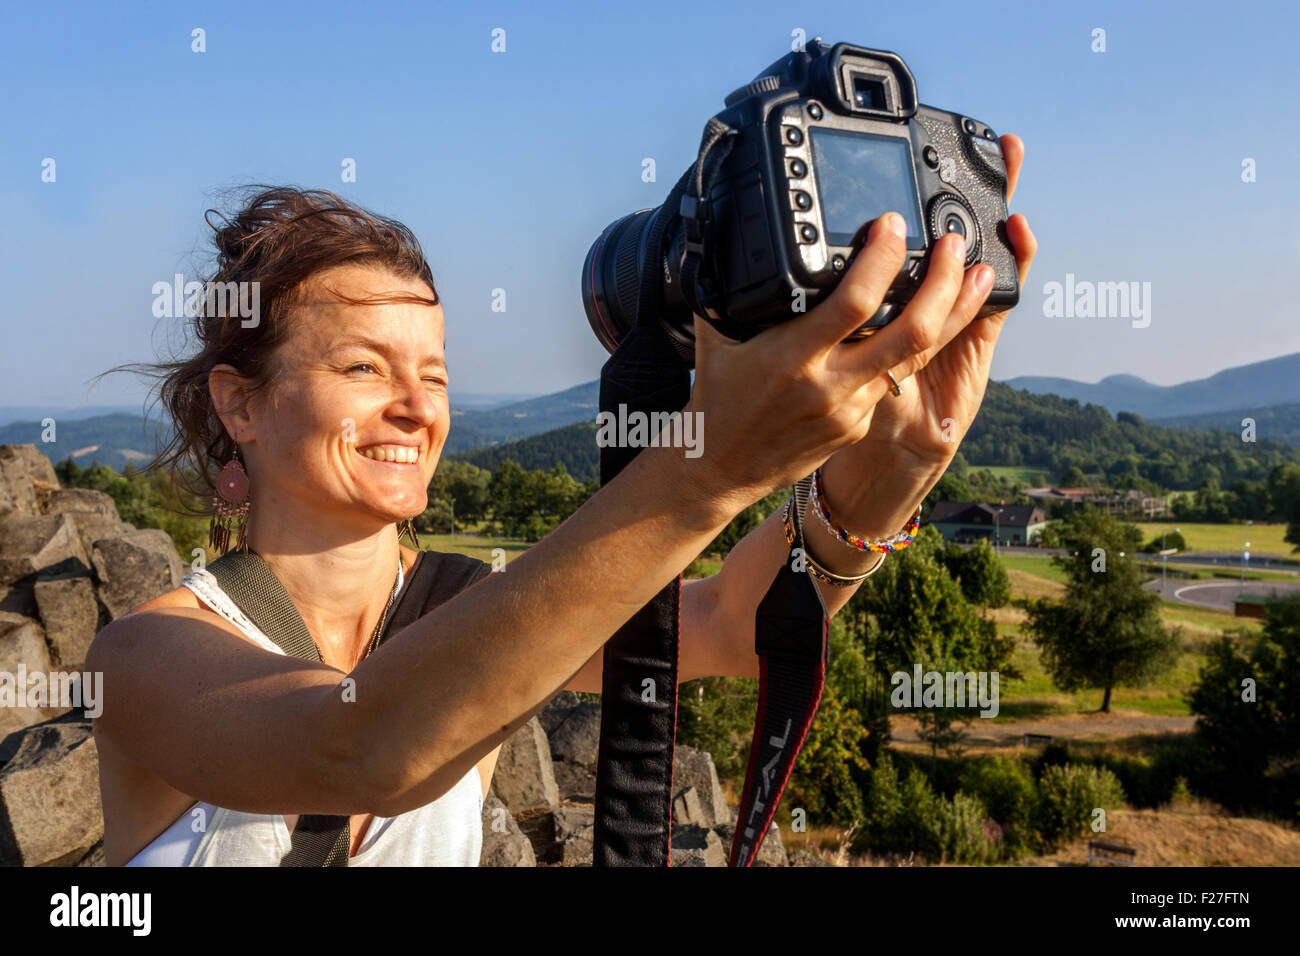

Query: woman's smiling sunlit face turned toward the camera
[[228, 265, 451, 533]]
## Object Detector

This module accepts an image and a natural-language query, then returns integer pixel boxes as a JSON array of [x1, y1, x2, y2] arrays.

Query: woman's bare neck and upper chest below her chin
[[237, 489, 416, 672]]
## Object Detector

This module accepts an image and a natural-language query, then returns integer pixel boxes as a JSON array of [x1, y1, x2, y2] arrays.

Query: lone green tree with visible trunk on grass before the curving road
[[1027, 509, 1182, 713]]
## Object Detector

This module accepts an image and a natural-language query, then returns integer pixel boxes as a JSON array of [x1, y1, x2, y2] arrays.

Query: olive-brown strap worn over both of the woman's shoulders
[[208, 551, 491, 866]]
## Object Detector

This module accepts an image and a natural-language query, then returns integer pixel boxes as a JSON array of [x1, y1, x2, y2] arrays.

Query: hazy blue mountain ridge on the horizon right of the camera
[[1005, 352, 1300, 418]]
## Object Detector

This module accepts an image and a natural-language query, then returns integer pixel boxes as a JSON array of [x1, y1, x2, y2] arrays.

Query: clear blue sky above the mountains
[[0, 0, 1300, 407]]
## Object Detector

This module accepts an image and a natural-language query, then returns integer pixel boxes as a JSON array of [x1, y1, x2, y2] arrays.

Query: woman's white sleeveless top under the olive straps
[[126, 568, 482, 866]]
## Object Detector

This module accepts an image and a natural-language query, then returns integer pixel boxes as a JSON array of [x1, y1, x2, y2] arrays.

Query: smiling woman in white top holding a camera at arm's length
[[86, 137, 1036, 865]]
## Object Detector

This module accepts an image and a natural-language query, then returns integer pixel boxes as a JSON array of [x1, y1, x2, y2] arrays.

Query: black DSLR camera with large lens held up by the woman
[[582, 39, 1019, 367]]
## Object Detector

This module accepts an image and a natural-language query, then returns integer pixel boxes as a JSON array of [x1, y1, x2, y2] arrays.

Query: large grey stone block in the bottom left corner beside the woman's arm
[[0, 719, 104, 866]]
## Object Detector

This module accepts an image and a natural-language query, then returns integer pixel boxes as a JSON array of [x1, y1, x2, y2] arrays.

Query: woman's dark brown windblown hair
[[127, 186, 438, 498]]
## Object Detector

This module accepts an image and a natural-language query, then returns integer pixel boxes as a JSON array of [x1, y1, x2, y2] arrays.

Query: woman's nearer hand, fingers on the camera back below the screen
[[673, 184, 984, 512]]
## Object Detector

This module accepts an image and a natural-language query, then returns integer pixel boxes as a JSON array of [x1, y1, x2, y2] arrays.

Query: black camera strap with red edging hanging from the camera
[[593, 117, 828, 866]]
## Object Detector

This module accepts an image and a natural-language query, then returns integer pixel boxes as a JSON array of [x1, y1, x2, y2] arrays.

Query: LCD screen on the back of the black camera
[[813, 126, 926, 248]]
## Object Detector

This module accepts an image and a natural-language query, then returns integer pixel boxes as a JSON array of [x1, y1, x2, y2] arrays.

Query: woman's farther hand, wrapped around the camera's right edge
[[823, 135, 1037, 537]]
